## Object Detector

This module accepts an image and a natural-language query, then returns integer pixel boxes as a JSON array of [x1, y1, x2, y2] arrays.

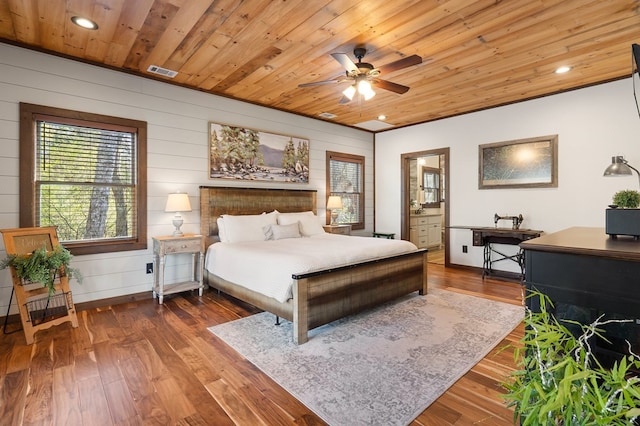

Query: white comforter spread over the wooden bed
[[205, 233, 417, 302]]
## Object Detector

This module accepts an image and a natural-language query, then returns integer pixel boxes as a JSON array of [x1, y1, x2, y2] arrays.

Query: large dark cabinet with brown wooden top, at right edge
[[520, 227, 640, 370]]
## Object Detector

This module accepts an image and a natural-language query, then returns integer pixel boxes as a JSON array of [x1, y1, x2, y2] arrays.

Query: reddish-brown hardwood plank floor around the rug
[[0, 264, 523, 426]]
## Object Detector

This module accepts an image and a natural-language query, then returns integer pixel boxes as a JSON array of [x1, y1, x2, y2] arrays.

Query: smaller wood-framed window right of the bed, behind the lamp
[[327, 151, 364, 229]]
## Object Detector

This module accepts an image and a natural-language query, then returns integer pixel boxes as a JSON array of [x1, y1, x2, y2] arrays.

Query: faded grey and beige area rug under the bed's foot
[[209, 289, 524, 426]]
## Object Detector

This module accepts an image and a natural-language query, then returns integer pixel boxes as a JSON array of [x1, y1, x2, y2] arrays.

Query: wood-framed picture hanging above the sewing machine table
[[478, 135, 558, 189]]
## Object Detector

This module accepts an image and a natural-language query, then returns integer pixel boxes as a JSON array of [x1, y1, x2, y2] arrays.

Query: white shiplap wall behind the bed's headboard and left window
[[0, 43, 373, 316]]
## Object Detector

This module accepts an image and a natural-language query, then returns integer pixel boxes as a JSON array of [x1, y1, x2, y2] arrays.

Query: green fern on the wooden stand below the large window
[[0, 245, 82, 294]]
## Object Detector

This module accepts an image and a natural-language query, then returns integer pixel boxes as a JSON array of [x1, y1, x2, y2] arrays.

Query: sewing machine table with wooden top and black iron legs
[[471, 228, 542, 279]]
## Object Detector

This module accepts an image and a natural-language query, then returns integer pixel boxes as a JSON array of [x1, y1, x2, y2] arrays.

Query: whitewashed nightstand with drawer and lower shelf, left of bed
[[153, 234, 204, 304]]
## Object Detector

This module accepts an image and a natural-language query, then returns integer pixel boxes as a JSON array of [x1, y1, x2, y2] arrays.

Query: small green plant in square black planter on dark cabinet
[[605, 189, 640, 240]]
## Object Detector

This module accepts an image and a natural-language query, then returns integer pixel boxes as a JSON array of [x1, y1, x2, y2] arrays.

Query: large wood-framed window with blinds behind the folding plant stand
[[20, 103, 147, 254]]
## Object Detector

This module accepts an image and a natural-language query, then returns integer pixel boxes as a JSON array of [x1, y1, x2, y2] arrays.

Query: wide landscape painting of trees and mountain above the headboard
[[209, 122, 309, 183]]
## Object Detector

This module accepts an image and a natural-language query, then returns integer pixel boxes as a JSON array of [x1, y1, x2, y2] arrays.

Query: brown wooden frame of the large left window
[[19, 102, 147, 255]]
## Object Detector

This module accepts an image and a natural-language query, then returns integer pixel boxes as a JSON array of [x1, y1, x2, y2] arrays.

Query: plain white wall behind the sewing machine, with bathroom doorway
[[375, 78, 640, 271]]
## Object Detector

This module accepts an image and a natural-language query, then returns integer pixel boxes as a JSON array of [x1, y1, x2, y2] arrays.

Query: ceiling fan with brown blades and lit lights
[[298, 47, 422, 104]]
